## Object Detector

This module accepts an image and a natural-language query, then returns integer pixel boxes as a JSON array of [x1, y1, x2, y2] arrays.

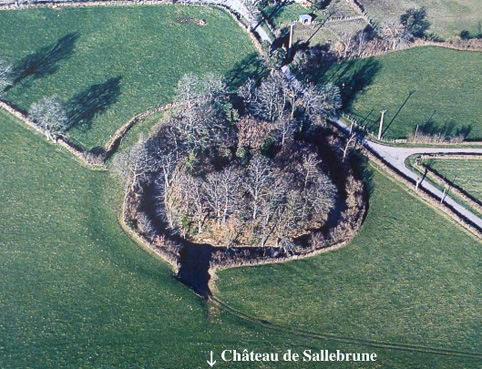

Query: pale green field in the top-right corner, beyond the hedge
[[359, 0, 482, 38]]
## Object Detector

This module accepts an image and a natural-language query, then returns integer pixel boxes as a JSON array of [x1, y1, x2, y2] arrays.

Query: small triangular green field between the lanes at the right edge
[[425, 158, 482, 201]]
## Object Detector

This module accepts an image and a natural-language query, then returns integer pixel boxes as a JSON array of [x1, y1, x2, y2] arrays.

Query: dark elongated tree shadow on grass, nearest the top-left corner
[[13, 32, 79, 87]]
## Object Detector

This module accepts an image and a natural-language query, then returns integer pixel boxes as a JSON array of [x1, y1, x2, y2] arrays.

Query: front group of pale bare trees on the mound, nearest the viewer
[[169, 151, 336, 247]]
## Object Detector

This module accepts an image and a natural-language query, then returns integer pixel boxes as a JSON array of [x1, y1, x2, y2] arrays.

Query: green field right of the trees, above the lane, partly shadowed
[[310, 47, 482, 139]]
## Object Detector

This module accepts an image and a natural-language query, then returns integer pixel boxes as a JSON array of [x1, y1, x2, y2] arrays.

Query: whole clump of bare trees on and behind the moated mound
[[112, 73, 340, 248]]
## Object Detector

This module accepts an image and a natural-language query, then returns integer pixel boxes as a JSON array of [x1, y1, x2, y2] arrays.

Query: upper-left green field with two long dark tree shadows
[[0, 5, 255, 149]]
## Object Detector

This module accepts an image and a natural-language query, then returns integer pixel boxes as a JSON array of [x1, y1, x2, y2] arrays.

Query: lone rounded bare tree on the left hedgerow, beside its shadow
[[29, 95, 69, 141]]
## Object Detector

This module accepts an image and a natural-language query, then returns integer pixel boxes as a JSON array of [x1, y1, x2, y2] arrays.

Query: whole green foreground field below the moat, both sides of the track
[[0, 103, 481, 369]]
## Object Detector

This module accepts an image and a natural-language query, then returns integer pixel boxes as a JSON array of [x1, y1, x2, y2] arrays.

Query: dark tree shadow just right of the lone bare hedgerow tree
[[67, 76, 122, 131]]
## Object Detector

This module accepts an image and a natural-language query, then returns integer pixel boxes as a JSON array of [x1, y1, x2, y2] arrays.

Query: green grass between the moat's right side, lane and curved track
[[217, 165, 482, 368]]
